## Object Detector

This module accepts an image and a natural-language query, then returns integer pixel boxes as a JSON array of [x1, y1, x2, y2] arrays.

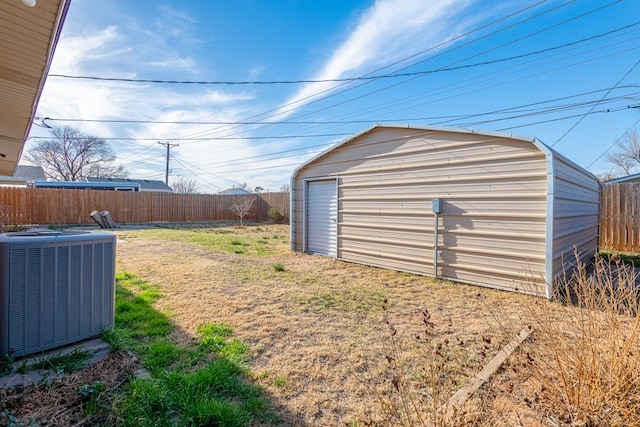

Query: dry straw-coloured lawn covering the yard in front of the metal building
[[5, 225, 640, 427]]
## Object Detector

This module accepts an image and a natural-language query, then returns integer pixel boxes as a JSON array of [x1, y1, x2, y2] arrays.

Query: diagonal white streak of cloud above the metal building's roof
[[278, 0, 472, 120]]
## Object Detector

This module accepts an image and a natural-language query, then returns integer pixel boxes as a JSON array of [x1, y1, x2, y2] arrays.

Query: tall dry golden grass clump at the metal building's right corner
[[504, 252, 640, 426]]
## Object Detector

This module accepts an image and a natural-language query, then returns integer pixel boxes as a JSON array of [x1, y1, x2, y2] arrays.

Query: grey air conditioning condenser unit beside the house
[[0, 230, 116, 357]]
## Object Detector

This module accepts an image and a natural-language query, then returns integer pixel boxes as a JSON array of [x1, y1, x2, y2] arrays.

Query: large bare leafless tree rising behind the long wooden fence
[[24, 126, 127, 181]]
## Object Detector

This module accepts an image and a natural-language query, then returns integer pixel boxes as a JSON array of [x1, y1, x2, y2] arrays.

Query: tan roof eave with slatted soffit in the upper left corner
[[0, 0, 70, 176]]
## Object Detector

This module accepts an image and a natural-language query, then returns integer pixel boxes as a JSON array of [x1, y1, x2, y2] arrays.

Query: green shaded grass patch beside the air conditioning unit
[[104, 273, 292, 426]]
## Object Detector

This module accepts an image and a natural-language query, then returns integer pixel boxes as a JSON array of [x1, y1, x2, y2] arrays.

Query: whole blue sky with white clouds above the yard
[[26, 0, 640, 192]]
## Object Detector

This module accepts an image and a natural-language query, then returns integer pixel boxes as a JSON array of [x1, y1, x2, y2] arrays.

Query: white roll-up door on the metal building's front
[[307, 179, 338, 257]]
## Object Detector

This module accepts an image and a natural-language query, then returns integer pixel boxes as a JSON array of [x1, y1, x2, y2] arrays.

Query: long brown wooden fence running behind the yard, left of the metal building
[[0, 187, 289, 225]]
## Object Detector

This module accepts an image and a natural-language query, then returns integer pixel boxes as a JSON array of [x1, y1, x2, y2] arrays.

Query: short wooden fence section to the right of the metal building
[[600, 183, 640, 252]]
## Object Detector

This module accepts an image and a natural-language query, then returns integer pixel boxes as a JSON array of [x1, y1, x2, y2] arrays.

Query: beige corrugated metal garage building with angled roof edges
[[291, 126, 600, 297]]
